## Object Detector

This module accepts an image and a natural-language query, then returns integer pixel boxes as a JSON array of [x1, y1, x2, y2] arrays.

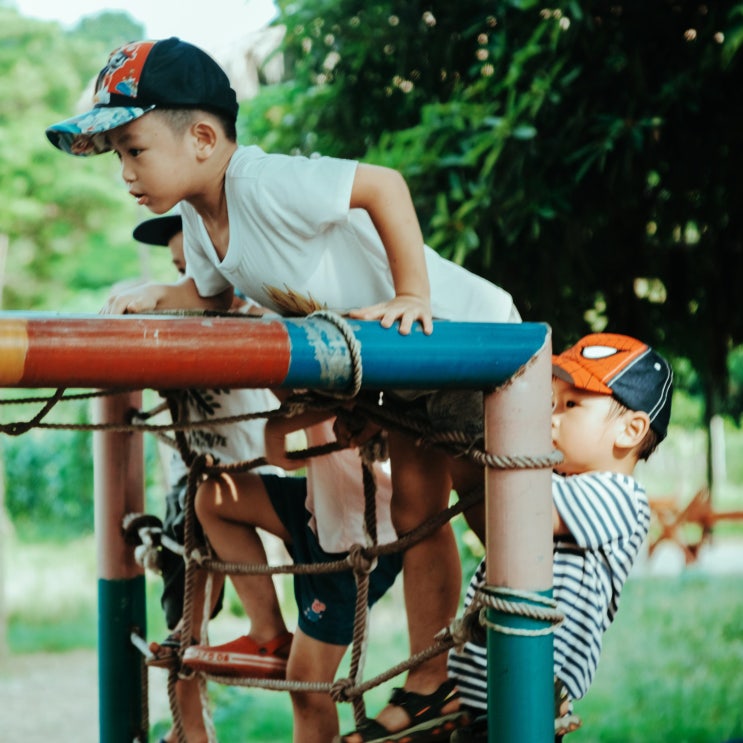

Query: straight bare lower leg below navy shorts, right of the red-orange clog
[[287, 629, 347, 743]]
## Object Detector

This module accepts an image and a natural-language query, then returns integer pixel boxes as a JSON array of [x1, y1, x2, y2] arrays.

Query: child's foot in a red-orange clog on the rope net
[[183, 632, 292, 679]]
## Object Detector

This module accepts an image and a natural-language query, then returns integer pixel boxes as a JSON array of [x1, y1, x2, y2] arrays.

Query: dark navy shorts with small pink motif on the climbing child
[[261, 475, 402, 645]]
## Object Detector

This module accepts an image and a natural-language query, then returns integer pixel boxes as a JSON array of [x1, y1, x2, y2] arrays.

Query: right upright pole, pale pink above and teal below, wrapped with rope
[[485, 336, 554, 743]]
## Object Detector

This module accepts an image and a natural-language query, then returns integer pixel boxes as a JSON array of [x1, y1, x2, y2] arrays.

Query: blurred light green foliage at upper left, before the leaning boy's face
[[0, 7, 154, 311]]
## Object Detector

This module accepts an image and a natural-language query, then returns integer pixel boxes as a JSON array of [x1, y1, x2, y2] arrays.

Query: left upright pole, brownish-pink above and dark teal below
[[93, 392, 146, 743]]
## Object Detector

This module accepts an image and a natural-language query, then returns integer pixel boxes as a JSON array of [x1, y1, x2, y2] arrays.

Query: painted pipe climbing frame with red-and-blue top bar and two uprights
[[0, 313, 554, 743]]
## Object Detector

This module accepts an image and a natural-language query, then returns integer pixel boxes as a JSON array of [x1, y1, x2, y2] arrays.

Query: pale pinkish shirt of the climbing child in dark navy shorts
[[305, 420, 397, 552]]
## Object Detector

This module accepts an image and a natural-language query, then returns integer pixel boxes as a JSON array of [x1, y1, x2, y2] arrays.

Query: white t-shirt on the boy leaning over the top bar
[[181, 146, 519, 322]]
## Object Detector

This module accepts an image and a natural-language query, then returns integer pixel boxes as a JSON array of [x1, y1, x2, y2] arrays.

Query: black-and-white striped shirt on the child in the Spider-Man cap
[[449, 472, 650, 710]]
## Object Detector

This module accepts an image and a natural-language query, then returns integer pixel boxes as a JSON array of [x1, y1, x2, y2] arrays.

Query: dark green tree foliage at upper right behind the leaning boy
[[244, 0, 743, 428]]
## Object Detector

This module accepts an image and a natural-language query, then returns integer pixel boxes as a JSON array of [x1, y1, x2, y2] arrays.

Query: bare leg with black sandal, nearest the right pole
[[377, 431, 462, 731]]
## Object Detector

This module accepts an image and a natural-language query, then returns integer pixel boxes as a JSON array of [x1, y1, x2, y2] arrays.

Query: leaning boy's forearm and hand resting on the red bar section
[[101, 278, 233, 315]]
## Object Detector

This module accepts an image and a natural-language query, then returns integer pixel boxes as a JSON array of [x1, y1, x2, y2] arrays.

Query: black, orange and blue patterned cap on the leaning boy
[[46, 37, 238, 155]]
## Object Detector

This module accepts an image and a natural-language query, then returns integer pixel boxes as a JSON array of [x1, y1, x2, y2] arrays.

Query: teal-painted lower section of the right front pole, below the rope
[[487, 591, 555, 743]]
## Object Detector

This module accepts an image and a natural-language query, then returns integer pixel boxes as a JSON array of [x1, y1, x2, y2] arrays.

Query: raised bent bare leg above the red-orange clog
[[196, 473, 289, 643]]
